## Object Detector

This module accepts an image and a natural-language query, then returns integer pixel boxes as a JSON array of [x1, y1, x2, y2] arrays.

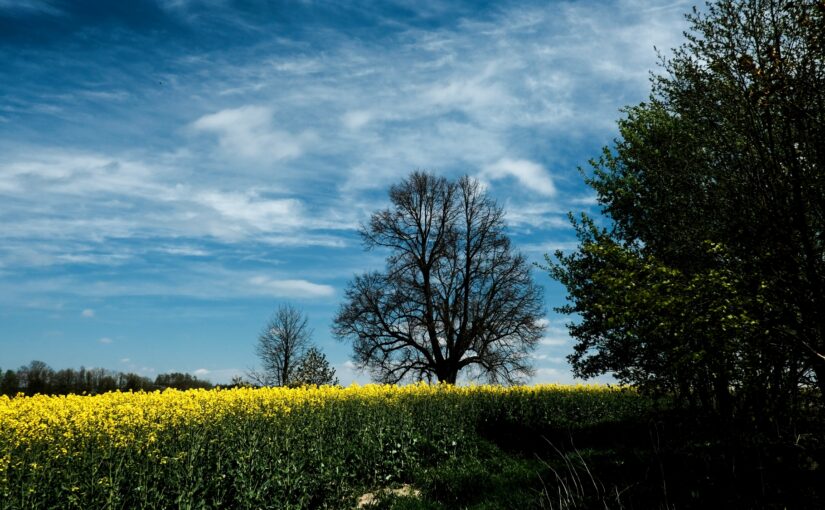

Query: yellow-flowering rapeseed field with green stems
[[0, 384, 647, 509]]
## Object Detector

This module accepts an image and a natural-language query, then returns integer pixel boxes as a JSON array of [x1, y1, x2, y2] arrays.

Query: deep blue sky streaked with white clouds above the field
[[0, 0, 691, 384]]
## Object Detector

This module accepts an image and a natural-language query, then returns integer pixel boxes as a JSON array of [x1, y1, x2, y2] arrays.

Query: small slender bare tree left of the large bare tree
[[248, 304, 312, 386]]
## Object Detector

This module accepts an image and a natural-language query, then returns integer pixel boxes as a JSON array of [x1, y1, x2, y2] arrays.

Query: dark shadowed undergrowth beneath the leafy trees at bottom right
[[372, 410, 825, 510]]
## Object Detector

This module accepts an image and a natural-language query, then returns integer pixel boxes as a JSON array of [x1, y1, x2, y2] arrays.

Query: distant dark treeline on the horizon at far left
[[0, 361, 213, 396]]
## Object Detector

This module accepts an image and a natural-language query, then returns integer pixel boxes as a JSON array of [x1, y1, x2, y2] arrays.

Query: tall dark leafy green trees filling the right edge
[[550, 0, 825, 410]]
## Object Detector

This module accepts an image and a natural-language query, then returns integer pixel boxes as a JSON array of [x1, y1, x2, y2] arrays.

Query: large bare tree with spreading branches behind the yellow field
[[333, 172, 544, 383]]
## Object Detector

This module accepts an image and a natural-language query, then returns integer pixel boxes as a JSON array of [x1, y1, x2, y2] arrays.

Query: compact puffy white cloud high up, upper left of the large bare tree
[[192, 105, 315, 161]]
